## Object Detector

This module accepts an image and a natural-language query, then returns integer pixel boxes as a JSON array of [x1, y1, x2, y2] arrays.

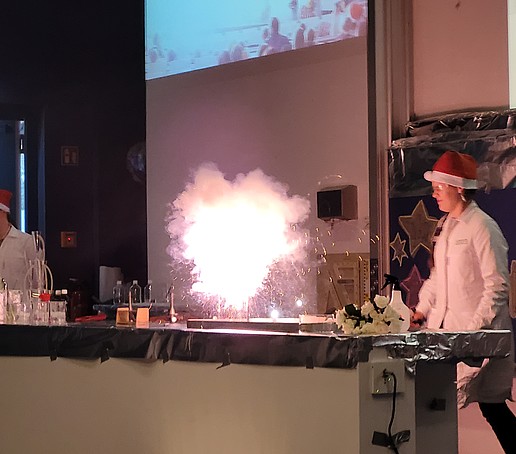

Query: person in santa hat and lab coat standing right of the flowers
[[412, 151, 516, 454]]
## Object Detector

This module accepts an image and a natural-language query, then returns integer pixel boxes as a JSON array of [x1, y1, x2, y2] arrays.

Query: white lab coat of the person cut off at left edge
[[0, 226, 36, 290]]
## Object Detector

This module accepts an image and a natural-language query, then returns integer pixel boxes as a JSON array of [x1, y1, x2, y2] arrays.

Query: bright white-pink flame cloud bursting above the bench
[[168, 164, 310, 309]]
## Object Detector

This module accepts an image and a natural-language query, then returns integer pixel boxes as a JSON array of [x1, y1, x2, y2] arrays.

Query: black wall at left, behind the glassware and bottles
[[0, 0, 147, 294]]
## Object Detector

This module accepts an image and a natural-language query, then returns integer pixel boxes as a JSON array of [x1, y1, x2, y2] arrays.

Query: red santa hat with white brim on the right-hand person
[[423, 151, 478, 189]]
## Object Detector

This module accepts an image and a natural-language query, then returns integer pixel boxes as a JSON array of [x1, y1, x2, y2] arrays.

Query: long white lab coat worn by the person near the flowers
[[416, 202, 514, 407]]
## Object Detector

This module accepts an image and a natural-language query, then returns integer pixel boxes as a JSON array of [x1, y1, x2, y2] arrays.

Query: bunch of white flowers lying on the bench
[[335, 295, 403, 335]]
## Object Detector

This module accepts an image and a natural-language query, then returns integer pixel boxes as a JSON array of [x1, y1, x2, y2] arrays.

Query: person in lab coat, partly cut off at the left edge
[[0, 189, 36, 290]]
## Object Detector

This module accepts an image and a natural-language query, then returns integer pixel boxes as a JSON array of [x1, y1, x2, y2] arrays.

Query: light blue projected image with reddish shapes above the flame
[[145, 0, 367, 80]]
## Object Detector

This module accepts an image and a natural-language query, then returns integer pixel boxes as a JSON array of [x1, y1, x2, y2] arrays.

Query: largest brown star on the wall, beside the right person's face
[[398, 200, 438, 257]]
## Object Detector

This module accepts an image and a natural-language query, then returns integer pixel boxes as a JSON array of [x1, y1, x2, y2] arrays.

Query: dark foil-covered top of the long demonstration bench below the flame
[[0, 321, 512, 368]]
